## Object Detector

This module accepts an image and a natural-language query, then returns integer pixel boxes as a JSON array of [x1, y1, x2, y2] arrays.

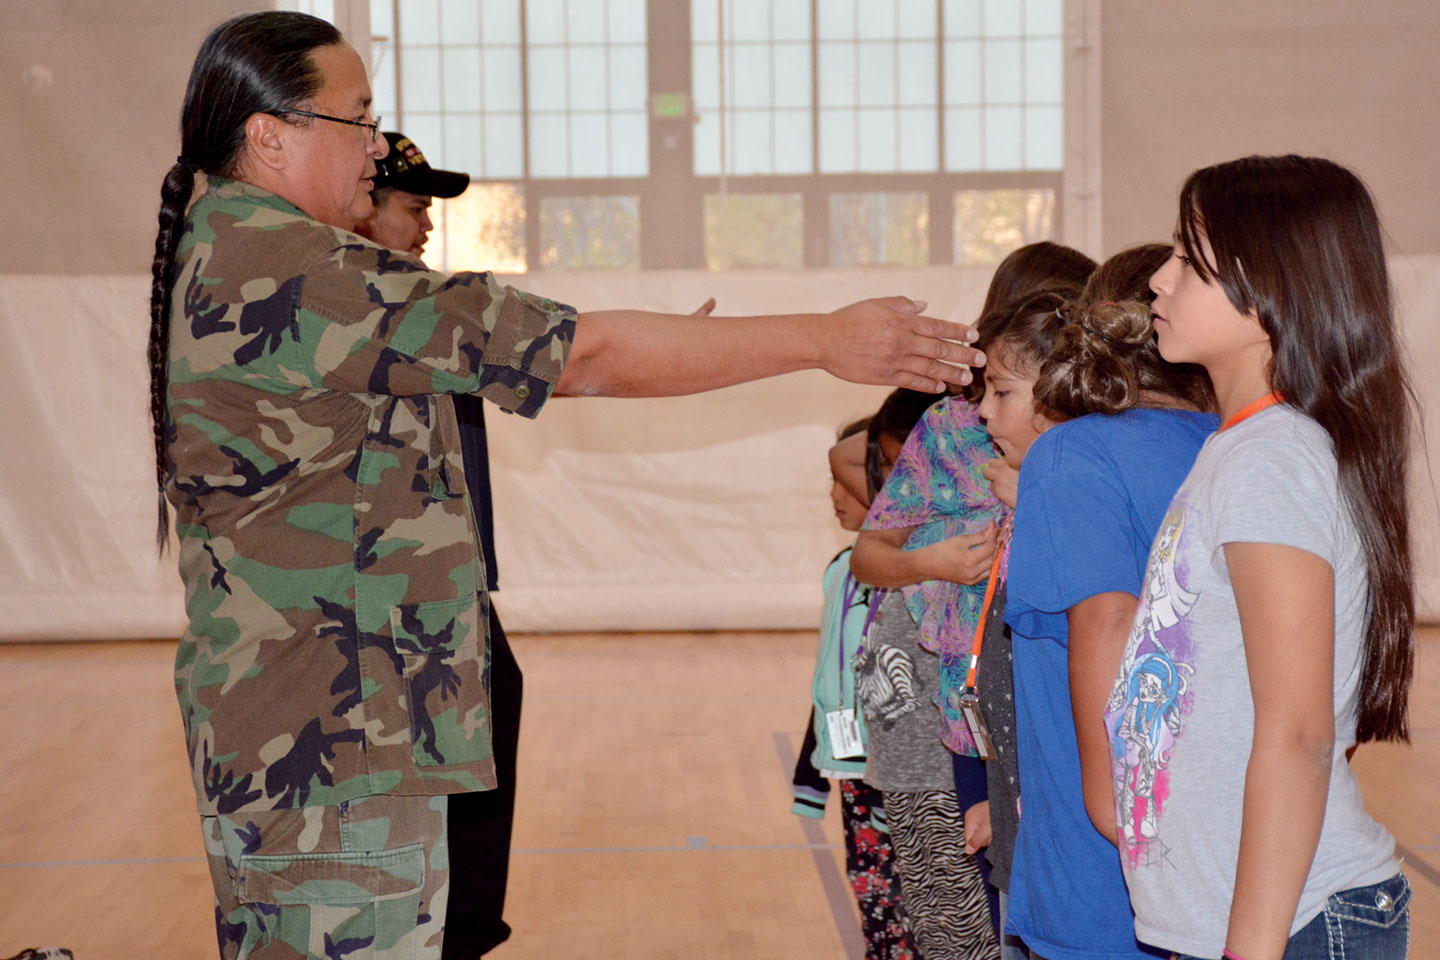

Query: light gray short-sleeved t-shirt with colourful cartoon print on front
[[1106, 406, 1398, 957]]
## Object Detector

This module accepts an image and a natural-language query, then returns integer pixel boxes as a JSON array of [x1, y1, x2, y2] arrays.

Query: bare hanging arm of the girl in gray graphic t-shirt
[[1225, 543, 1335, 960]]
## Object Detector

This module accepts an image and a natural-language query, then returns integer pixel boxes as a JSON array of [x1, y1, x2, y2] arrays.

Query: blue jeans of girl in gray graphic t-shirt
[[1175, 874, 1410, 960]]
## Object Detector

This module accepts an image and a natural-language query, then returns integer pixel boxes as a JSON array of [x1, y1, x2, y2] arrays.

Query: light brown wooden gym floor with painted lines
[[0, 629, 1440, 960]]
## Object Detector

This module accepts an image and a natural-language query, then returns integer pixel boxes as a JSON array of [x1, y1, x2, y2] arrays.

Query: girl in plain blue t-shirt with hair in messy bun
[[979, 245, 1217, 960]]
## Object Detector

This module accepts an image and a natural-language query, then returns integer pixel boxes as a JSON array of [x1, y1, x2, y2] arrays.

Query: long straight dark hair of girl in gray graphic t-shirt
[[1178, 155, 1416, 743]]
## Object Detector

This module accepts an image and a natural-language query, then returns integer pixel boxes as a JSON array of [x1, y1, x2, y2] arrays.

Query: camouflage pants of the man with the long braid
[[200, 796, 449, 960]]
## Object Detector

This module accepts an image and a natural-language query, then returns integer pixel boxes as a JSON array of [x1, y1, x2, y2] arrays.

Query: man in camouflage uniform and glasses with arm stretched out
[[164, 13, 973, 960]]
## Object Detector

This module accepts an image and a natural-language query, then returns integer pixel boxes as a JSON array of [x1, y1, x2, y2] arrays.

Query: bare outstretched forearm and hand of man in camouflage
[[556, 296, 984, 397]]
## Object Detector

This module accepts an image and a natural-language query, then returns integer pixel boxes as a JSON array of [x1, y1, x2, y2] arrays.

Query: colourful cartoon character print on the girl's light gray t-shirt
[[1104, 501, 1200, 865]]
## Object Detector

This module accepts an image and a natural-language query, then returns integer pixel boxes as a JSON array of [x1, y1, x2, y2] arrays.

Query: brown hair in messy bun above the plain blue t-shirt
[[1035, 243, 1214, 420]]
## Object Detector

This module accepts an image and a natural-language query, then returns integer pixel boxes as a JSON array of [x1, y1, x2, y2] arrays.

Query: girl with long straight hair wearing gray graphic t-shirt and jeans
[[1107, 155, 1416, 960]]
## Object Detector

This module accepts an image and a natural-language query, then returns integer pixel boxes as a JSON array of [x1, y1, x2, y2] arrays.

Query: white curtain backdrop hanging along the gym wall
[[0, 256, 1440, 639]]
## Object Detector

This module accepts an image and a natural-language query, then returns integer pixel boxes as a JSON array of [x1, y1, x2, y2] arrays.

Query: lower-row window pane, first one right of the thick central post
[[704, 193, 805, 271]]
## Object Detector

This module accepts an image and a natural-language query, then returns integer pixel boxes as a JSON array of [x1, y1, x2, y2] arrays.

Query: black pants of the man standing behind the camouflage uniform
[[442, 607, 524, 960]]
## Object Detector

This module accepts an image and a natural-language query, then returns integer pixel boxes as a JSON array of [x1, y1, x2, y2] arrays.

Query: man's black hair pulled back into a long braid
[[148, 12, 341, 553]]
